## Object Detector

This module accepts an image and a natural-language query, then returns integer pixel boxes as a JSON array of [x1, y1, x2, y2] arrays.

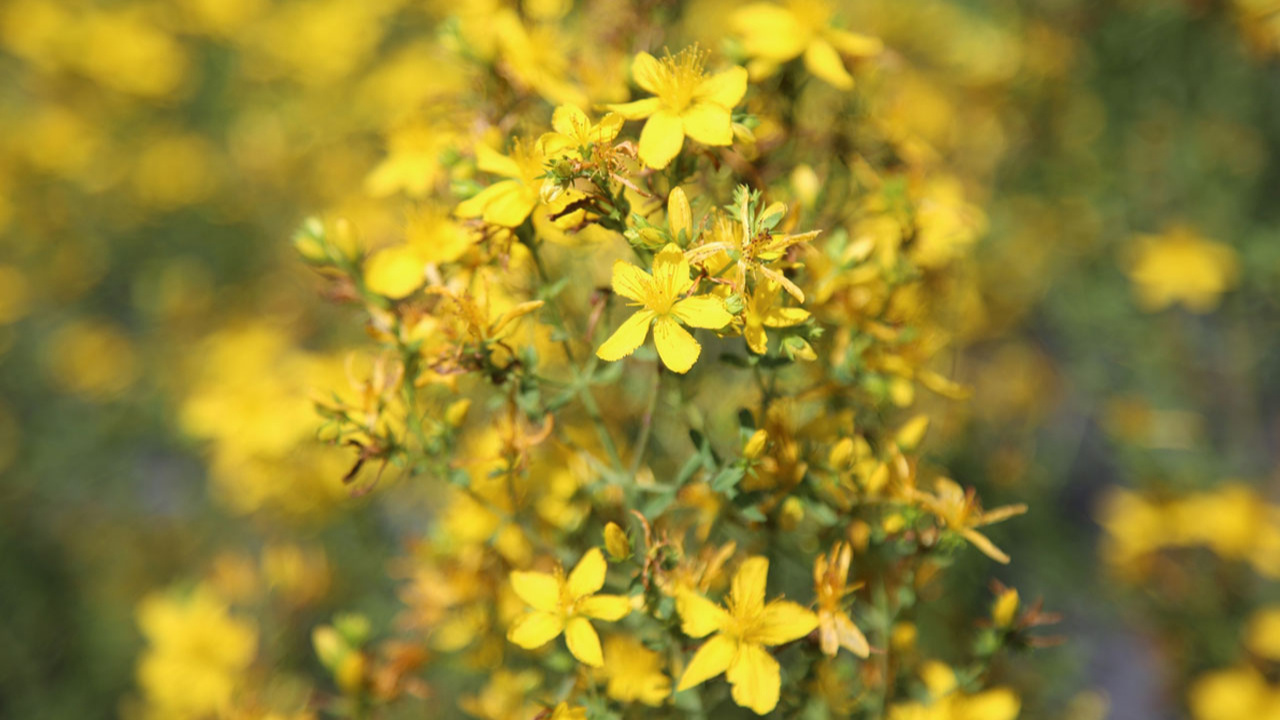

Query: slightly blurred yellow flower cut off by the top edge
[[730, 0, 882, 90]]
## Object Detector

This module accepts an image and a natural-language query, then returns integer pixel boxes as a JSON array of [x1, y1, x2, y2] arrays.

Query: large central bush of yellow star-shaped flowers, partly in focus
[[270, 4, 1042, 720]]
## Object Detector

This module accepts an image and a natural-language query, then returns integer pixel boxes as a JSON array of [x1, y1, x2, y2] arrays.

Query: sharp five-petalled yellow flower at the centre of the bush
[[595, 245, 733, 373]]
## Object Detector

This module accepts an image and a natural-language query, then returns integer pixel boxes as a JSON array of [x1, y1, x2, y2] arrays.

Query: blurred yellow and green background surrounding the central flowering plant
[[0, 0, 1280, 720]]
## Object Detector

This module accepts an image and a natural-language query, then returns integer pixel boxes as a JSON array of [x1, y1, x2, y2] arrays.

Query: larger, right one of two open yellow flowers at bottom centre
[[676, 557, 818, 715]]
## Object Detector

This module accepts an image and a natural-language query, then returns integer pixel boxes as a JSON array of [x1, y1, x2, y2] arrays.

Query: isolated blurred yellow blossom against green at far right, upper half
[[1126, 228, 1239, 313]]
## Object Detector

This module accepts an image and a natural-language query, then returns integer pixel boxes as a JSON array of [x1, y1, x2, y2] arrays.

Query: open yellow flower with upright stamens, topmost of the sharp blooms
[[609, 47, 746, 169]]
